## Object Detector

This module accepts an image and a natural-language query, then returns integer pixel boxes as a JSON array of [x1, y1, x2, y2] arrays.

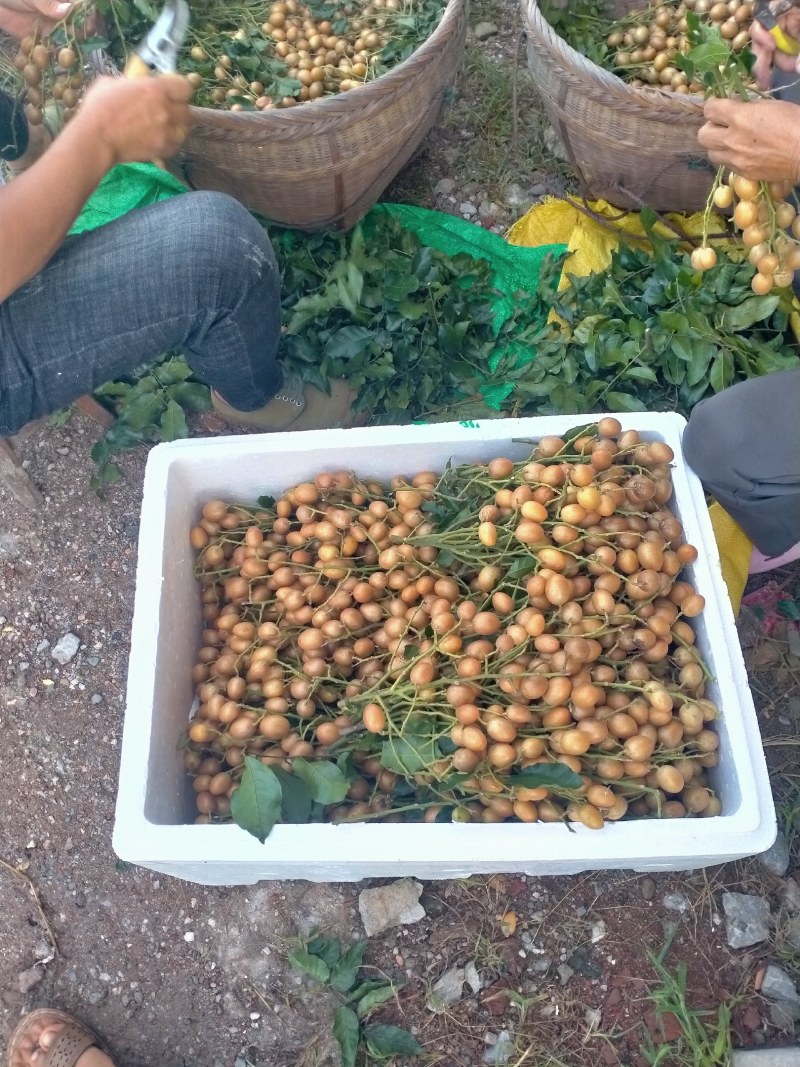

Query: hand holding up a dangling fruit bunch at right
[[698, 98, 800, 185]]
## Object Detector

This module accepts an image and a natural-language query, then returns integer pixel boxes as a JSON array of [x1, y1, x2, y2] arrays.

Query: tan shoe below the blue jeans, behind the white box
[[211, 371, 355, 433]]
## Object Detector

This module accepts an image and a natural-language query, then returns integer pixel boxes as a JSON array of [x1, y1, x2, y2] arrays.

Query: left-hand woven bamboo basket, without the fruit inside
[[181, 0, 468, 230]]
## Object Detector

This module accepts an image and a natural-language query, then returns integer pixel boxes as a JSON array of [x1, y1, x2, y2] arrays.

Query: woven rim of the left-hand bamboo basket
[[190, 0, 467, 136]]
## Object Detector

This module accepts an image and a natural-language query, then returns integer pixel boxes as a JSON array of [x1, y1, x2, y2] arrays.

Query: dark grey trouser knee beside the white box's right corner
[[684, 368, 800, 556]]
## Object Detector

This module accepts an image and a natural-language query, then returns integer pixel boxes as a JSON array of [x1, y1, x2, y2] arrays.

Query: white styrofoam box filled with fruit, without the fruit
[[114, 414, 775, 885]]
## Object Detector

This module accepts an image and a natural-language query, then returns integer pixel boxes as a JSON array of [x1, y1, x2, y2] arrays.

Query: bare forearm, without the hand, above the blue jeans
[[0, 116, 114, 301]]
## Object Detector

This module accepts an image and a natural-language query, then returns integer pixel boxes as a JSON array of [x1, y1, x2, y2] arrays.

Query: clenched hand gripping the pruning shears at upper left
[[71, 74, 192, 166]]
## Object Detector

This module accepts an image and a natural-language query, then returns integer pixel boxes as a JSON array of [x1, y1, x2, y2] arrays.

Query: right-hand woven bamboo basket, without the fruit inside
[[521, 0, 714, 211]]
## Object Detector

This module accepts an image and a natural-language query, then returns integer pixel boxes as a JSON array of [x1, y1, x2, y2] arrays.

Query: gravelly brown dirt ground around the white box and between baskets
[[0, 4, 800, 1067]]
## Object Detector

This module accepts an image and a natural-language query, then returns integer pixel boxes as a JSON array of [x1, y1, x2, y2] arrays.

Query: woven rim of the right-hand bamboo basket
[[523, 0, 705, 118]]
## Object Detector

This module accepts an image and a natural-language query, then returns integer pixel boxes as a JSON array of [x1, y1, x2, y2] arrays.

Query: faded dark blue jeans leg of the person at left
[[0, 192, 282, 435]]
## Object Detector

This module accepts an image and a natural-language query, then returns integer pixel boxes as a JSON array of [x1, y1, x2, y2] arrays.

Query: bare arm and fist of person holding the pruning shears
[[0, 75, 192, 301]]
